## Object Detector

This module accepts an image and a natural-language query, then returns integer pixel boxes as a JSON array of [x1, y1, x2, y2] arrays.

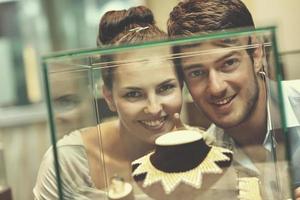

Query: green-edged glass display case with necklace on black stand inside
[[39, 27, 300, 200]]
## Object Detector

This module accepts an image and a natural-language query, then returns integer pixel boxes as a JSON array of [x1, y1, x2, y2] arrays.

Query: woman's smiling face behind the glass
[[103, 49, 182, 144]]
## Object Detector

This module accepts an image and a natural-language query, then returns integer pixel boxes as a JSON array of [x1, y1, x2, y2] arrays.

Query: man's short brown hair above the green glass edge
[[168, 0, 255, 37]]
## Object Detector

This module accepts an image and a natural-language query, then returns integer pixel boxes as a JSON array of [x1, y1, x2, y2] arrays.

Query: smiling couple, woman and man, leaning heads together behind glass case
[[34, 0, 300, 199]]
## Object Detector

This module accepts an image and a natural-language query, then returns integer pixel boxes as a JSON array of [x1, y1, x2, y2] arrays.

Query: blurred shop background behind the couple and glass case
[[0, 0, 300, 200]]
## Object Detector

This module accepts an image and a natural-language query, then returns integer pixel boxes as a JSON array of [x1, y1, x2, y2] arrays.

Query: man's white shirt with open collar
[[207, 80, 300, 199]]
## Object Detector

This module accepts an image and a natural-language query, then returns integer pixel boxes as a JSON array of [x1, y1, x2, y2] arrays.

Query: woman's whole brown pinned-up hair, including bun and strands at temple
[[97, 6, 168, 89]]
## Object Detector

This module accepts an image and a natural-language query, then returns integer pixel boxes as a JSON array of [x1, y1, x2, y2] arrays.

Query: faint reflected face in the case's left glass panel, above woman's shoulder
[[48, 63, 96, 138]]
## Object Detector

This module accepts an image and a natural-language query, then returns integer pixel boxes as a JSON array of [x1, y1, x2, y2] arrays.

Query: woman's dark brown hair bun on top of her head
[[97, 6, 155, 46]]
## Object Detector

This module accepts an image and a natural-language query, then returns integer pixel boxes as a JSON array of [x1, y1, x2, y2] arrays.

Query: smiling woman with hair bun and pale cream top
[[34, 6, 186, 199]]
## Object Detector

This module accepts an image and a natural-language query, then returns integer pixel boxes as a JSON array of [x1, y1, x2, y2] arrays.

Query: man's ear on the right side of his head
[[251, 36, 264, 73]]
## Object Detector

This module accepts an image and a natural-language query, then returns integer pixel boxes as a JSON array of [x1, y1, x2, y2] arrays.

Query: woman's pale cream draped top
[[33, 130, 149, 200]]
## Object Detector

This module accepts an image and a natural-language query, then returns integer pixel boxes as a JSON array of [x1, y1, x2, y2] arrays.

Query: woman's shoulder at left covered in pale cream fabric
[[33, 130, 93, 199]]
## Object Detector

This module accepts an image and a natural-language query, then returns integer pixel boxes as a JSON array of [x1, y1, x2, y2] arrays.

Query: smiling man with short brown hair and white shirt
[[168, 0, 300, 199]]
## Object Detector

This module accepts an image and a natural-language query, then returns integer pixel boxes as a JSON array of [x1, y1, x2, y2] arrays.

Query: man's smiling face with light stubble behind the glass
[[181, 38, 264, 133]]
